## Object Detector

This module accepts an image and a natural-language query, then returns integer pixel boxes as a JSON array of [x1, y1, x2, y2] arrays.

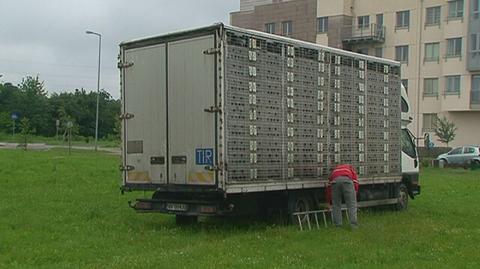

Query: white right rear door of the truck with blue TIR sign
[[167, 35, 216, 185]]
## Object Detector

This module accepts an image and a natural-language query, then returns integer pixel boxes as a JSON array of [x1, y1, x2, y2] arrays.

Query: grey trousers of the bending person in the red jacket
[[332, 177, 358, 227]]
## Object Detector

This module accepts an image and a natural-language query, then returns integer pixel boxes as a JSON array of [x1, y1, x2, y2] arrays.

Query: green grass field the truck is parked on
[[0, 150, 480, 268]]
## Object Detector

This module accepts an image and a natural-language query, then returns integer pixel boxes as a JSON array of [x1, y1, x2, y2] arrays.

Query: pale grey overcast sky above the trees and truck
[[0, 0, 240, 98]]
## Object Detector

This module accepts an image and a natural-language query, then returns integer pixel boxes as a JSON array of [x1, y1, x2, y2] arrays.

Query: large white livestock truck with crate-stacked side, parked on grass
[[119, 24, 420, 222]]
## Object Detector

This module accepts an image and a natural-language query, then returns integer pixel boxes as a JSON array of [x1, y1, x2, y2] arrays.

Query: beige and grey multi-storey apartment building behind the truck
[[230, 0, 480, 146]]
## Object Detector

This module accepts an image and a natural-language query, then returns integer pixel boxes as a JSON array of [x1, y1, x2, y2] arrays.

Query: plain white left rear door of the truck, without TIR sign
[[122, 44, 167, 185]]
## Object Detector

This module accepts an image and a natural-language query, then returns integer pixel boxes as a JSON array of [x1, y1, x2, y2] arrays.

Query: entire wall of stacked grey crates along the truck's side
[[224, 31, 401, 182]]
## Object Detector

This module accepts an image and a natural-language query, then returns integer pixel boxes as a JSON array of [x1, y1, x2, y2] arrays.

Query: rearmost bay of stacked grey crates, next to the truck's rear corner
[[225, 33, 286, 182]]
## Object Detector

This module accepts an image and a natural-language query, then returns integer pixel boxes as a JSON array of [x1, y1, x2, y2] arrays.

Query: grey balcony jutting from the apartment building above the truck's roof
[[342, 23, 385, 45]]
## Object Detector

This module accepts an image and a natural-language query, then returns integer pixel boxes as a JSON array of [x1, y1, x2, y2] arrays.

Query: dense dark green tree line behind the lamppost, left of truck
[[0, 76, 121, 138]]
